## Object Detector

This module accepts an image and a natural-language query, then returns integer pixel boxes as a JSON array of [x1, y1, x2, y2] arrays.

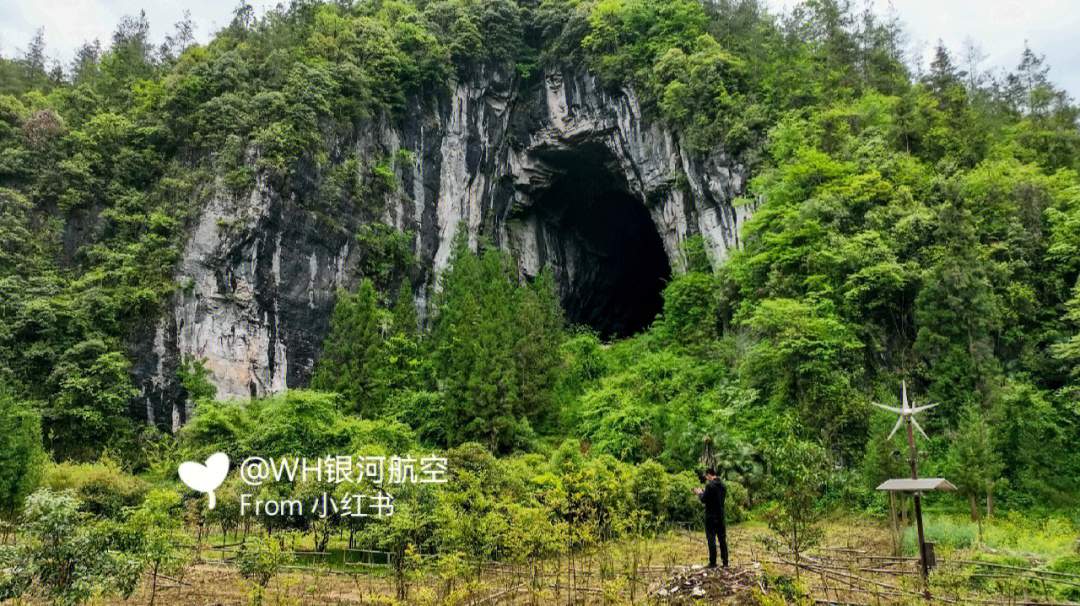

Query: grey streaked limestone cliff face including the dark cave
[[133, 69, 751, 429]]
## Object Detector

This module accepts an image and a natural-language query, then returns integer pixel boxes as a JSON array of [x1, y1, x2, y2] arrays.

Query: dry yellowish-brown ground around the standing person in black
[[8, 519, 1080, 606]]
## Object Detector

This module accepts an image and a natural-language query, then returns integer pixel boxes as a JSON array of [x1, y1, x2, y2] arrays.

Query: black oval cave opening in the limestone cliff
[[534, 144, 671, 339]]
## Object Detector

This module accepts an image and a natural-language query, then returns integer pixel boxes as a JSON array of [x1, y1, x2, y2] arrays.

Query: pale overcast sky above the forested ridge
[[0, 0, 1080, 99]]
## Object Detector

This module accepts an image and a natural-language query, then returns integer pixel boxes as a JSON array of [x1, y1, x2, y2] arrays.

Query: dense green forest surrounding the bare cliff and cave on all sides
[[0, 0, 1080, 603]]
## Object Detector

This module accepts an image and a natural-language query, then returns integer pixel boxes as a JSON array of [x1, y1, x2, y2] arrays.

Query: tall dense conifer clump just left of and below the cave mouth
[[431, 234, 564, 452]]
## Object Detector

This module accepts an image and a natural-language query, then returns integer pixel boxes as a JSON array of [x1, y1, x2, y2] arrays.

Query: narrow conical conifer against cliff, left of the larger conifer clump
[[311, 280, 382, 415]]
